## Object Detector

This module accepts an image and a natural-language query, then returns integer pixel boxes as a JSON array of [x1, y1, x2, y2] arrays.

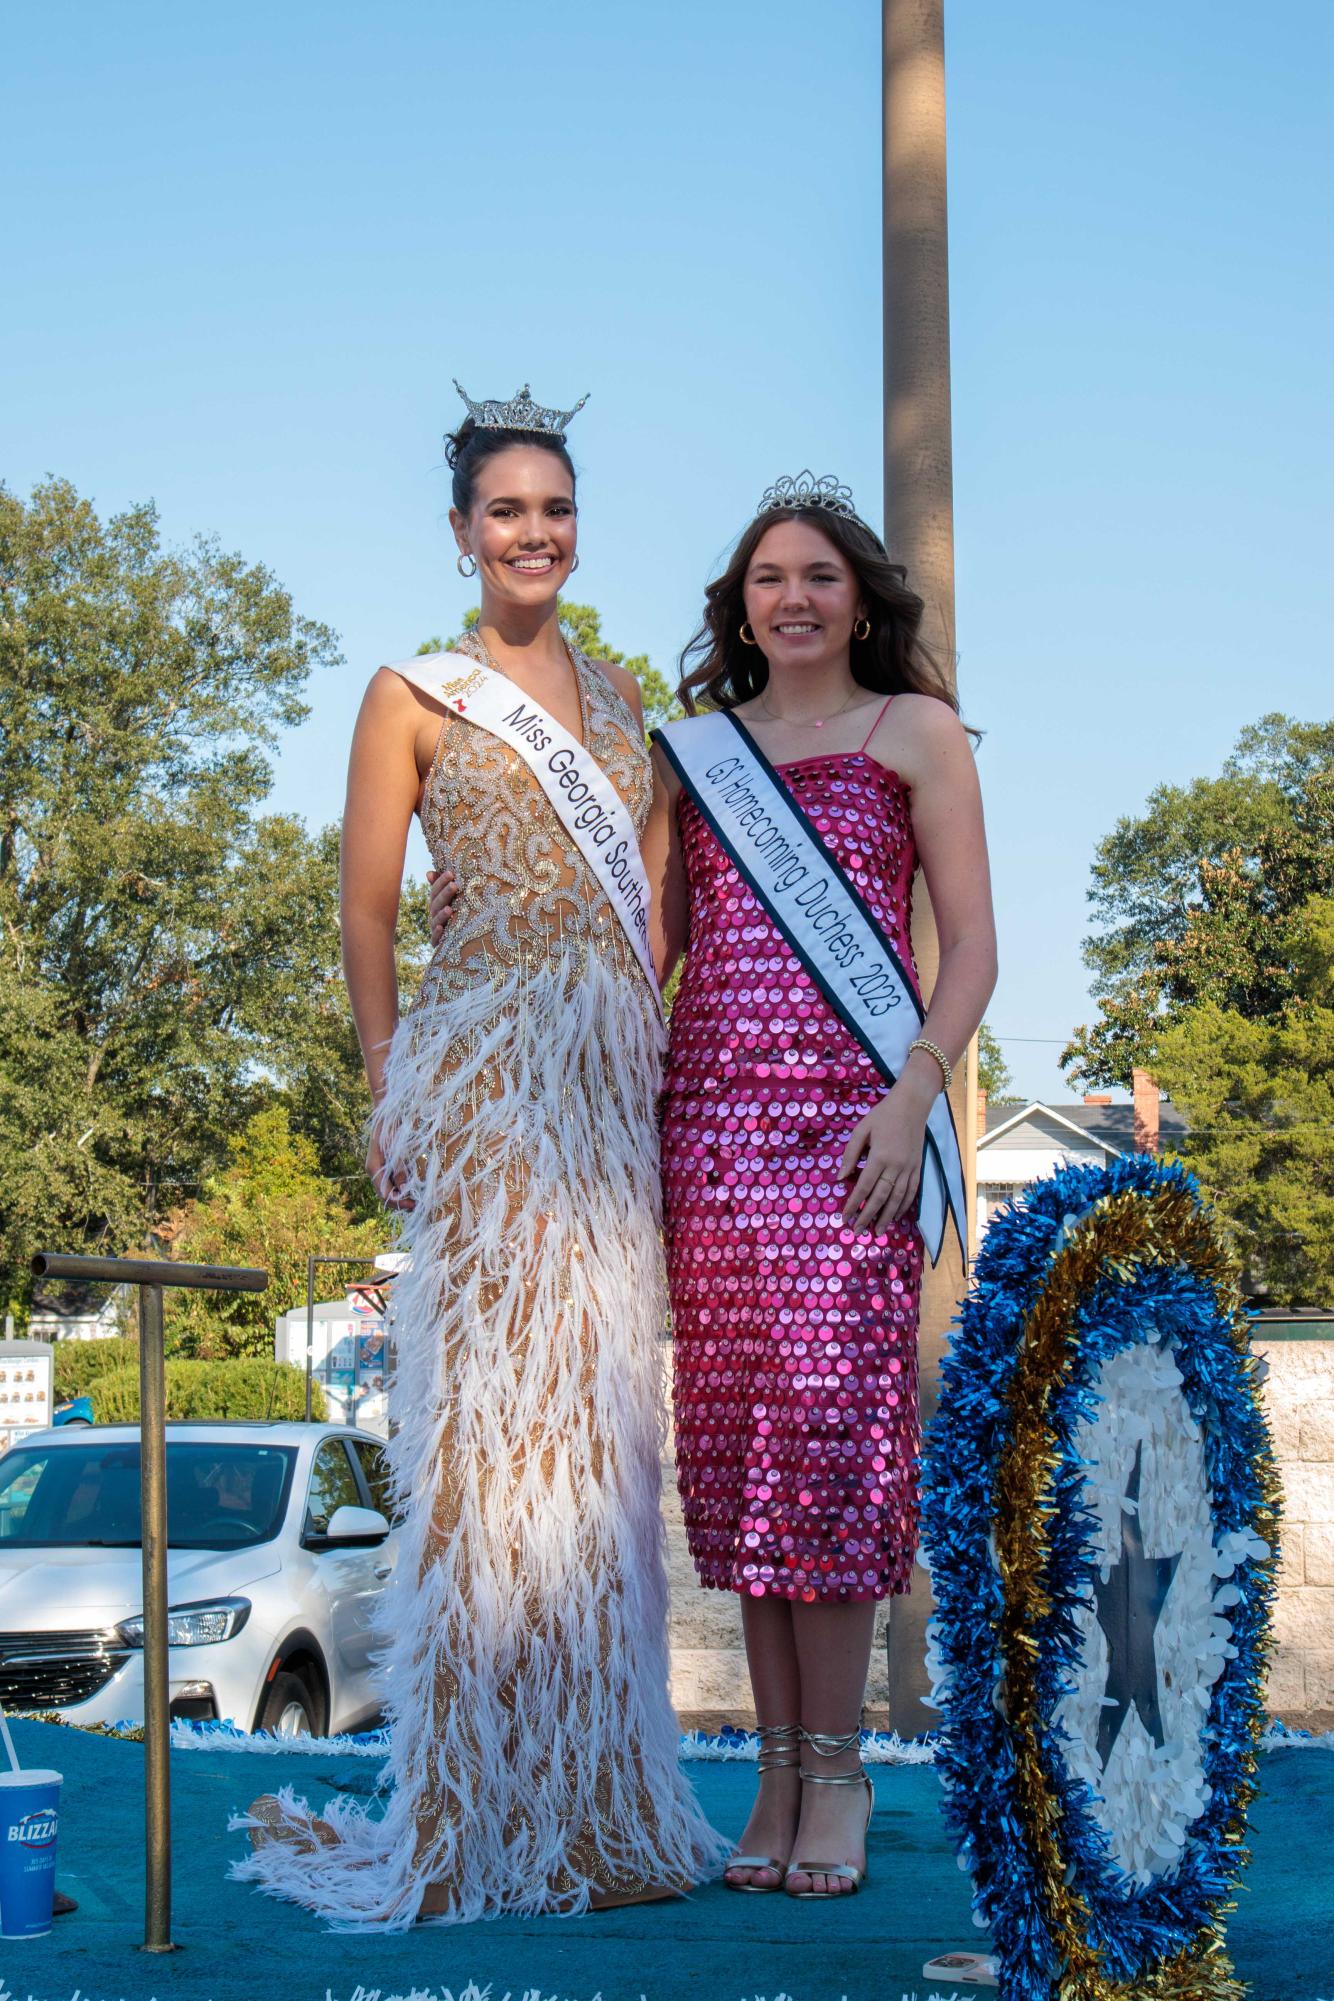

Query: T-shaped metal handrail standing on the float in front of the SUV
[[32, 1251, 268, 1953]]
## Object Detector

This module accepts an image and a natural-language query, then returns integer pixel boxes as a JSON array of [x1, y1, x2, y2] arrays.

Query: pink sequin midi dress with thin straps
[[662, 728, 922, 1603]]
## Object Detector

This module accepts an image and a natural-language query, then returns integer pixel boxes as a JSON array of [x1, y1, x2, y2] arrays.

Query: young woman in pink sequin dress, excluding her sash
[[646, 484, 996, 1897]]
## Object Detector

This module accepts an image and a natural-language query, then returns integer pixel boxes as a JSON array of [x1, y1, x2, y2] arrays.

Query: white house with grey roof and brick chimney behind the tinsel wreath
[[976, 1071, 1186, 1243]]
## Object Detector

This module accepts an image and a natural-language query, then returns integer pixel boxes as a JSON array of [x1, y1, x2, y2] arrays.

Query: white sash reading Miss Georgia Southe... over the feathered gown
[[392, 652, 658, 998]]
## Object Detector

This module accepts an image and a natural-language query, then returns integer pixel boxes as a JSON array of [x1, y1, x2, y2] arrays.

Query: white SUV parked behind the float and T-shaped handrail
[[0, 1423, 396, 1737]]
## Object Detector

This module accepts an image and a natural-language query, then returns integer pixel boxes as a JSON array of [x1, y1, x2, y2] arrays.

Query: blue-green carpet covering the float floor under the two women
[[0, 1723, 1334, 2001]]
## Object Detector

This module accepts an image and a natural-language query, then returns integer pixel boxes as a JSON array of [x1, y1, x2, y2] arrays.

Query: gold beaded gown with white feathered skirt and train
[[236, 640, 724, 1929]]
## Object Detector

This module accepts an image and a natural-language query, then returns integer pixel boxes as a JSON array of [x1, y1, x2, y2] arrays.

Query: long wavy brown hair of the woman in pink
[[676, 506, 958, 716]]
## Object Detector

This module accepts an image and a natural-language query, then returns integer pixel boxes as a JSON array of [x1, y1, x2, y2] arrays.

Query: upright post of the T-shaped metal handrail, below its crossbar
[[138, 1285, 172, 1953]]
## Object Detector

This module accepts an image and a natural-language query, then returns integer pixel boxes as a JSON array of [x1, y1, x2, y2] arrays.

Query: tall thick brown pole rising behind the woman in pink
[[882, 0, 976, 1735]]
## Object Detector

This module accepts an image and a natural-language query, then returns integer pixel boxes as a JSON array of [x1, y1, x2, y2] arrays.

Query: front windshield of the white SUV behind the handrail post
[[0, 1439, 296, 1551]]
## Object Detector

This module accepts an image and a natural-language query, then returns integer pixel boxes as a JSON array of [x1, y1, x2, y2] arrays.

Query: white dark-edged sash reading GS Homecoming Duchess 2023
[[654, 710, 968, 1265]]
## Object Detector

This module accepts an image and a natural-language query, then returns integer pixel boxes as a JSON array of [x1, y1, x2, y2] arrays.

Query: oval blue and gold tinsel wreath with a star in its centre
[[922, 1157, 1278, 2001]]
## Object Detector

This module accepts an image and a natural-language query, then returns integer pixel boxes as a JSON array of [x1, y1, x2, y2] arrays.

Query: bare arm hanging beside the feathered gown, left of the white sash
[[340, 668, 420, 1101]]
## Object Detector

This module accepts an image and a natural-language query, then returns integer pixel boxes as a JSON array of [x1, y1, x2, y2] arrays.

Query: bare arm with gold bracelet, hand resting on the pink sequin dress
[[840, 694, 996, 1229]]
